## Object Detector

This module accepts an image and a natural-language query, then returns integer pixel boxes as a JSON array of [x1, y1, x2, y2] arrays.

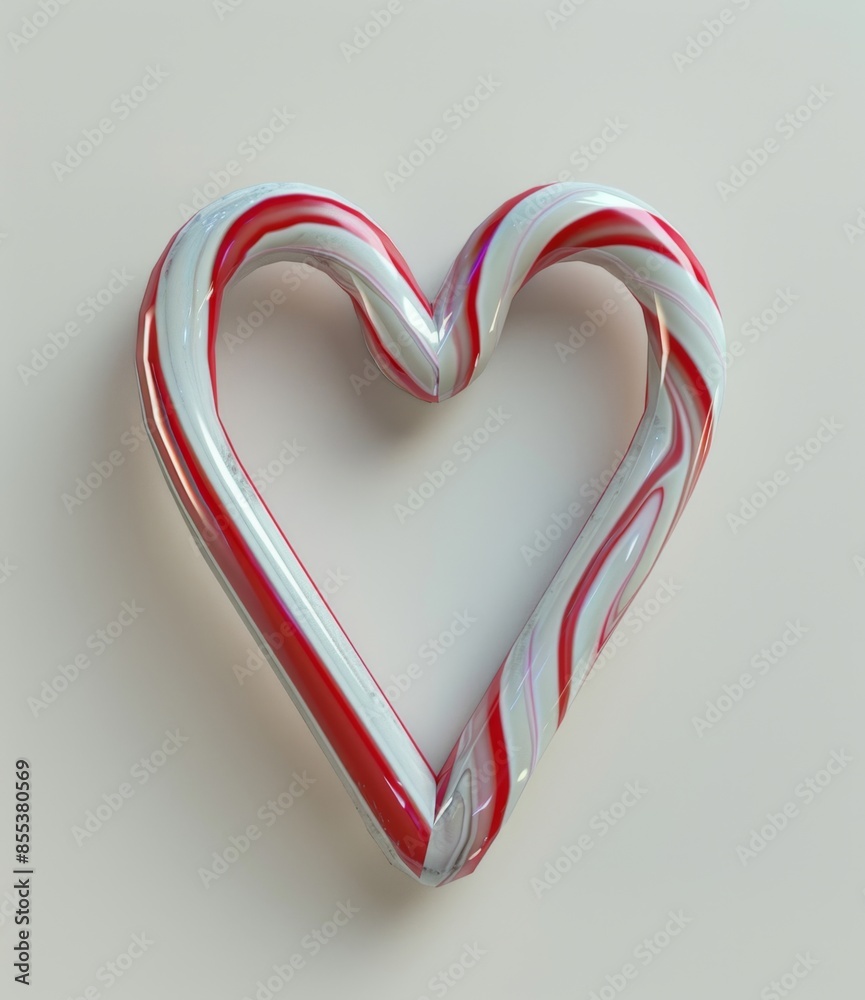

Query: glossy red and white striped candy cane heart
[[137, 183, 724, 885]]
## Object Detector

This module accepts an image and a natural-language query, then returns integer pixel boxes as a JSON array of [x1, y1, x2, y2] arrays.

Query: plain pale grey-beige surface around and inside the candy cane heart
[[0, 0, 865, 1000]]
